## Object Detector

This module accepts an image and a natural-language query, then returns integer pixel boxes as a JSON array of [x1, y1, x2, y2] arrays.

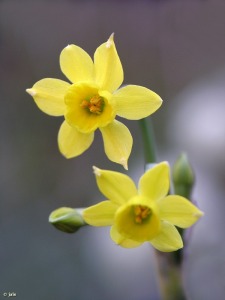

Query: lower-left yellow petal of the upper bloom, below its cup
[[58, 121, 94, 158]]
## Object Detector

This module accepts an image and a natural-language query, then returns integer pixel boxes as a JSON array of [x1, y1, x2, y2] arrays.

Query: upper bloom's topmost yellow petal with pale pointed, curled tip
[[94, 34, 123, 92]]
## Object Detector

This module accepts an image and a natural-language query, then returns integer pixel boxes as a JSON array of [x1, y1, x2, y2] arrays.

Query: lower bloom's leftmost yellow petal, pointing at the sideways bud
[[83, 201, 118, 226]]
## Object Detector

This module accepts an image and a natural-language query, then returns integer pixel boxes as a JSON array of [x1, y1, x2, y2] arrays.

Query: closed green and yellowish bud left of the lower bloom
[[49, 207, 87, 233]]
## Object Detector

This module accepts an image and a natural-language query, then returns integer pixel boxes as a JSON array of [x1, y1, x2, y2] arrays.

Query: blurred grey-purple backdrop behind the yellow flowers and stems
[[0, 0, 225, 300]]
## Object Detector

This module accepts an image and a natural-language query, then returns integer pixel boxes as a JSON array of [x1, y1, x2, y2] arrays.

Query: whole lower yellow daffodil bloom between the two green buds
[[83, 162, 203, 252]]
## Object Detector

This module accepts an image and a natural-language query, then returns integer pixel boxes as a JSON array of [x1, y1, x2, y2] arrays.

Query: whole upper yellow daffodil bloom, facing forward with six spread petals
[[27, 34, 162, 168]]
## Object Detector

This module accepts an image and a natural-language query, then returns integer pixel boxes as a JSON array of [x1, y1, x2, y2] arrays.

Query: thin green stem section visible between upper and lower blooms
[[139, 118, 156, 164]]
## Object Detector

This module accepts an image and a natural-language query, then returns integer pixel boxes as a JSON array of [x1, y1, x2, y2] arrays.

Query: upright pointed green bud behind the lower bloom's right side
[[172, 153, 195, 199]]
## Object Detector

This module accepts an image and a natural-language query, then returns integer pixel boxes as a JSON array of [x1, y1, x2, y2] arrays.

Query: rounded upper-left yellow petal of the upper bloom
[[60, 45, 94, 83]]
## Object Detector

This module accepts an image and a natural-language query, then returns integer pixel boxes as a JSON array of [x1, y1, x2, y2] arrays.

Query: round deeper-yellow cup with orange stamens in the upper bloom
[[64, 82, 116, 133]]
